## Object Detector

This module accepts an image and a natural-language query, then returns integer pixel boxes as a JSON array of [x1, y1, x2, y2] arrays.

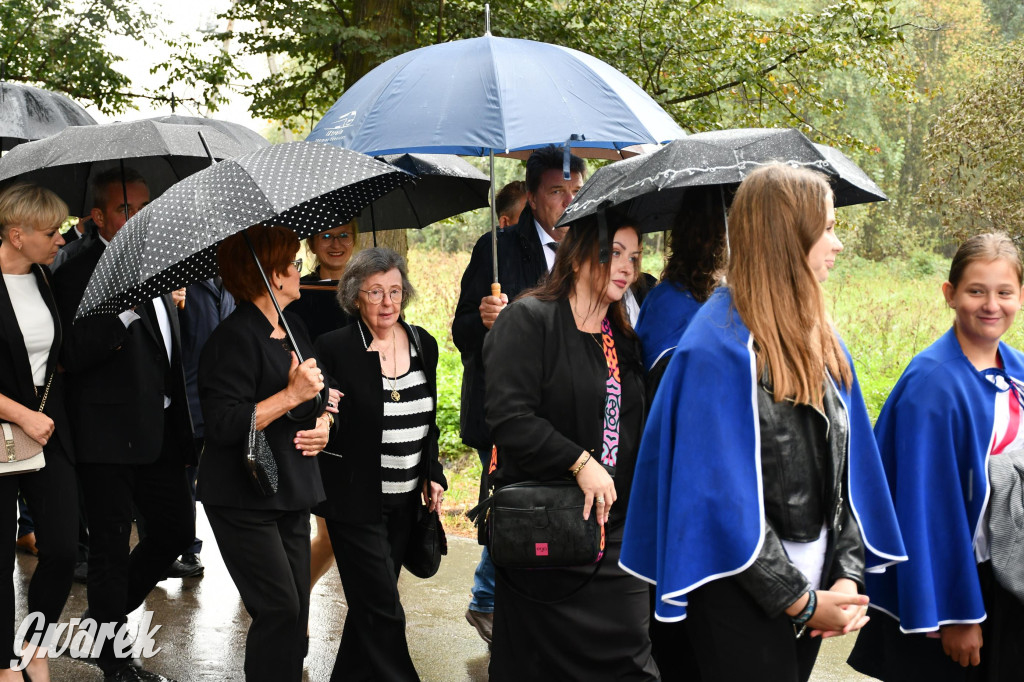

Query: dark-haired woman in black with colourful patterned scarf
[[483, 218, 657, 681]]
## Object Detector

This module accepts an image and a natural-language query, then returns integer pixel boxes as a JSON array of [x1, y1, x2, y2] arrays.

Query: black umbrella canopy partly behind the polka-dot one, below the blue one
[[359, 154, 490, 232]]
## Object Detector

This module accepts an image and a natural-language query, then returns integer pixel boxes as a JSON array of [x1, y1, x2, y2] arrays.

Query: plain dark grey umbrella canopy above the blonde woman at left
[[0, 121, 245, 216]]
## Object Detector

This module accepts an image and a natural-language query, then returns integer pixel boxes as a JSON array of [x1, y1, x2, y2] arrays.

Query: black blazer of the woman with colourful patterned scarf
[[483, 298, 645, 509]]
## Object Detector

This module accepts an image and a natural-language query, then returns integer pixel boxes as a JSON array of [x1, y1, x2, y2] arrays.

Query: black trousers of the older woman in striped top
[[327, 493, 420, 682]]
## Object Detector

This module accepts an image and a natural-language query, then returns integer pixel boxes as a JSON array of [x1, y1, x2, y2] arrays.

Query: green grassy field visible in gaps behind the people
[[408, 250, 1024, 535]]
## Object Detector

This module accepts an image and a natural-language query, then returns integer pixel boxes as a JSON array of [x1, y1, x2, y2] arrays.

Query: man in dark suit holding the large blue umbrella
[[452, 145, 587, 644]]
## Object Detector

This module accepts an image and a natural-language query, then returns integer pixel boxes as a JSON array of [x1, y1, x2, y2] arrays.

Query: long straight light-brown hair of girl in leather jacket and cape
[[727, 164, 853, 408]]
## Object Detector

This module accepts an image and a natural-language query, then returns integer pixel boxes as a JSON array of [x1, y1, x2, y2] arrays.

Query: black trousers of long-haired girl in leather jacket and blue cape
[[686, 578, 821, 682]]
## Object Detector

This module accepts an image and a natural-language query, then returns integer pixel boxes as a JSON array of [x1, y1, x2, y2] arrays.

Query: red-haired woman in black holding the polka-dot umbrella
[[197, 226, 333, 682]]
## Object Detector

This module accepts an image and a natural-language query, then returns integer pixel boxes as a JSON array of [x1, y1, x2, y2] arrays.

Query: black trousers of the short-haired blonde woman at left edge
[[0, 441, 78, 669]]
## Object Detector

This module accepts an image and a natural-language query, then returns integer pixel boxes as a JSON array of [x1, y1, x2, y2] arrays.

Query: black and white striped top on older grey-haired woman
[[381, 344, 434, 495]]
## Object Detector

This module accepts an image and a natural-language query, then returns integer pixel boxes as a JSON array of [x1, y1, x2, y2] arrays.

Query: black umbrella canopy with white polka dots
[[76, 142, 413, 317]]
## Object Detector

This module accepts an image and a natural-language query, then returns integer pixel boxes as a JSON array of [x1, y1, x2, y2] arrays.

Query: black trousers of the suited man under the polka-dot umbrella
[[76, 434, 196, 673]]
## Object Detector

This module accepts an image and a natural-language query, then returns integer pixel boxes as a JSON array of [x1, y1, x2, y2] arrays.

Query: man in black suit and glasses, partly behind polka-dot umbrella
[[54, 170, 196, 682]]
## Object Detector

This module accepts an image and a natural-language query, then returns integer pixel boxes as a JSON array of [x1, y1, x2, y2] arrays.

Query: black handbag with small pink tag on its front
[[484, 480, 604, 568]]
